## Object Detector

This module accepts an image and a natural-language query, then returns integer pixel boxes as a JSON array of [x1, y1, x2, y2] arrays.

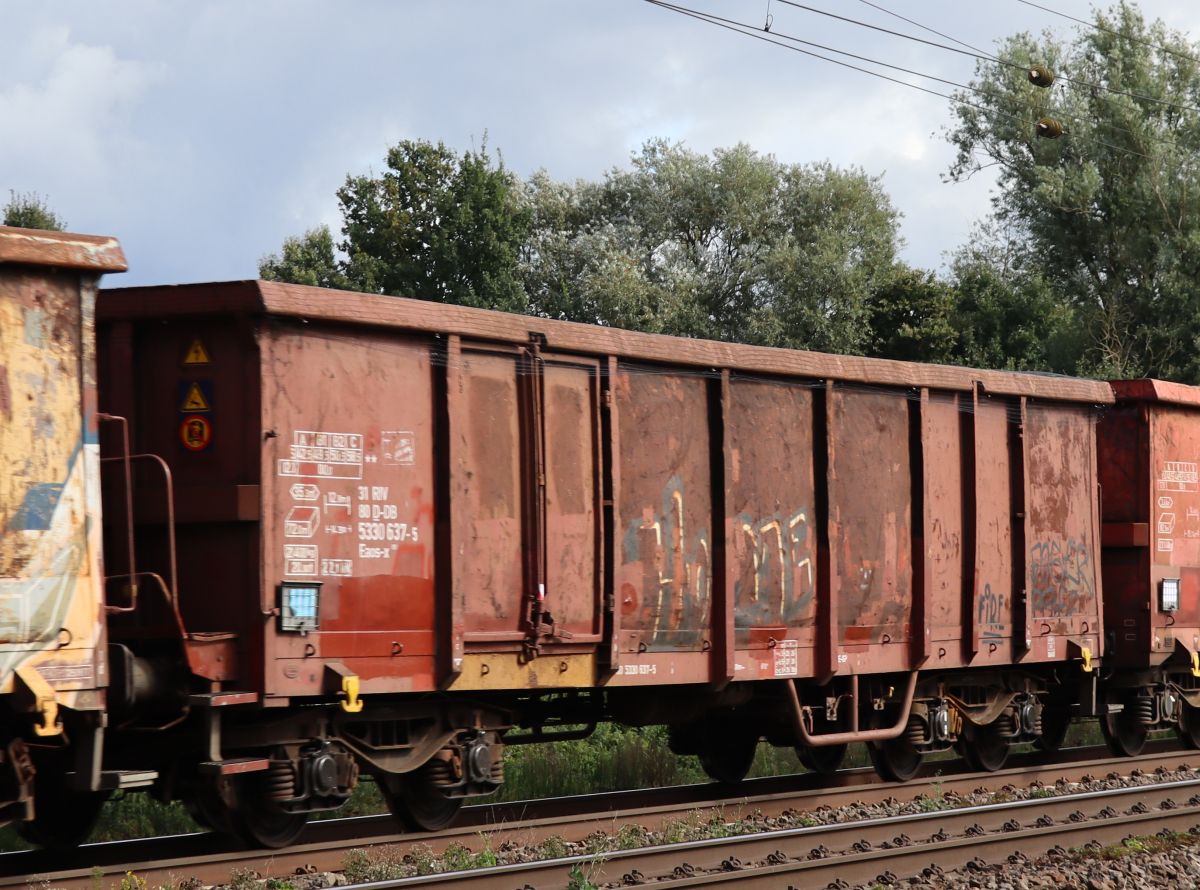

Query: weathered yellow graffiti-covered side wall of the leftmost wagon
[[0, 257, 109, 708]]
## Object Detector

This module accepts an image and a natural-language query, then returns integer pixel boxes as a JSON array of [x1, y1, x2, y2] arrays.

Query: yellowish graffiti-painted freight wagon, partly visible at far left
[[0, 228, 133, 841]]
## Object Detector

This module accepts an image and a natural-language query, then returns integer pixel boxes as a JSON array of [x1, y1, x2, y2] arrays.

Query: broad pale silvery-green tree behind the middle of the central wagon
[[522, 140, 898, 353]]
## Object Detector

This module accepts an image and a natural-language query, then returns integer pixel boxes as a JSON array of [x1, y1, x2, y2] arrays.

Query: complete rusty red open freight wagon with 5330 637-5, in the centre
[[91, 282, 1112, 842]]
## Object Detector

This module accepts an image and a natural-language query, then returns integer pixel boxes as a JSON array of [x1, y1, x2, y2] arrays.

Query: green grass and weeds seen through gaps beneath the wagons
[[0, 722, 1102, 852]]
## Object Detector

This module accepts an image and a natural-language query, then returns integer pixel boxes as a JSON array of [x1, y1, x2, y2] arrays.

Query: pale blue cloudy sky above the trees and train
[[0, 0, 1200, 284]]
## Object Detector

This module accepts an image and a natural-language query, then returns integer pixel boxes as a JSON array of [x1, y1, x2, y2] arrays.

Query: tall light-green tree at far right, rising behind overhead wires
[[949, 2, 1200, 381]]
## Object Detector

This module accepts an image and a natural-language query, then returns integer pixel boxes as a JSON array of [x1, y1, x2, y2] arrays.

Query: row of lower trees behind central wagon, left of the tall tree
[[259, 140, 1081, 372]]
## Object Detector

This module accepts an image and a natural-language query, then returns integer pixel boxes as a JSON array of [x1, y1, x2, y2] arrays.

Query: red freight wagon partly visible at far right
[[1099, 380, 1200, 754]]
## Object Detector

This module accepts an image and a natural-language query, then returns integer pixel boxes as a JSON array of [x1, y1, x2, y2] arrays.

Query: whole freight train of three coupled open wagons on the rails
[[7, 224, 1200, 846]]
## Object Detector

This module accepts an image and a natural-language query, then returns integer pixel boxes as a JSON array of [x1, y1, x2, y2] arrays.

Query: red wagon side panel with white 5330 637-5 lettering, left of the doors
[[260, 326, 437, 694]]
